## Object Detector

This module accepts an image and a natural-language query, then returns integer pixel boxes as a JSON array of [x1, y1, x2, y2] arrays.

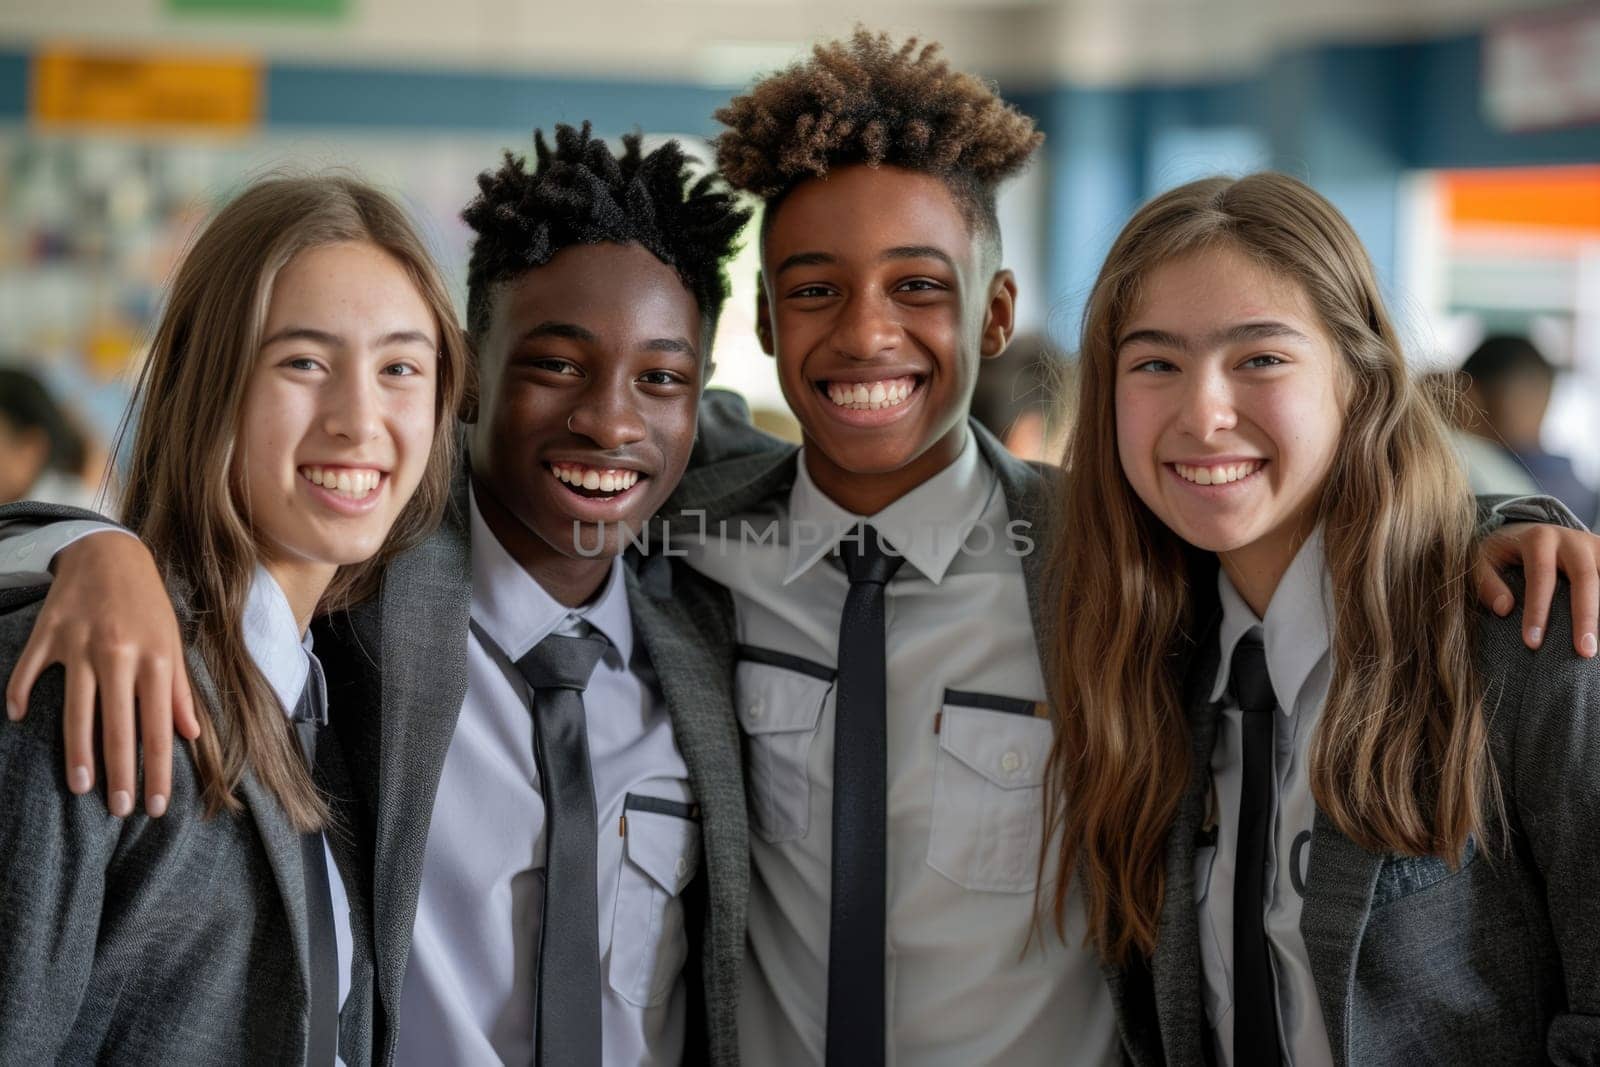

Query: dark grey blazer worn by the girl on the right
[[1107, 581, 1600, 1067]]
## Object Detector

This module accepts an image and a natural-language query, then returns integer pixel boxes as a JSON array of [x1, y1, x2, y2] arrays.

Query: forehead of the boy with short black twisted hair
[[490, 243, 701, 346]]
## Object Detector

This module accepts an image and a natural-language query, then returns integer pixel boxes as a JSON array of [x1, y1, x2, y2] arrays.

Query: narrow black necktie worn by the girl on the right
[[1230, 633, 1282, 1067]]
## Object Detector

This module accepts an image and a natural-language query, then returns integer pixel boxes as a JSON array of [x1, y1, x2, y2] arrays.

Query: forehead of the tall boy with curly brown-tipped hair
[[762, 163, 976, 267]]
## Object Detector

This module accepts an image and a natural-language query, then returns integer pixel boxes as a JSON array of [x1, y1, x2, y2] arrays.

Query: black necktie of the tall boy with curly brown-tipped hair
[[827, 526, 906, 1067]]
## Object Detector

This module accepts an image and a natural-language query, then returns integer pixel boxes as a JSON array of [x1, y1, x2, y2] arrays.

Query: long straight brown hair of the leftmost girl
[[122, 176, 470, 830]]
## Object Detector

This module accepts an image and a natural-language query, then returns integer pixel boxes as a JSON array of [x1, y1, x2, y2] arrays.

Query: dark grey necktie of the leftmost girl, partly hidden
[[293, 657, 339, 1067]]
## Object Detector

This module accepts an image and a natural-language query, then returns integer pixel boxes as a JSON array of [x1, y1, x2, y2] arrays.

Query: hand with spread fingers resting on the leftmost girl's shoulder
[[5, 531, 200, 816]]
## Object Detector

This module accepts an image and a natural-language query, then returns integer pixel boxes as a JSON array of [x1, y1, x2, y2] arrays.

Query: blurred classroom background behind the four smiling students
[[0, 0, 1600, 522]]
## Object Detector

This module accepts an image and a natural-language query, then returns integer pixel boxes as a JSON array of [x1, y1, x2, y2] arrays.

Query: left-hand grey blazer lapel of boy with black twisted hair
[[365, 472, 472, 1023]]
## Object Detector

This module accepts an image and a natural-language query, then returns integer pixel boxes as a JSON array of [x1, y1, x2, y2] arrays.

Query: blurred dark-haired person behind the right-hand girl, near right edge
[[1461, 334, 1600, 523]]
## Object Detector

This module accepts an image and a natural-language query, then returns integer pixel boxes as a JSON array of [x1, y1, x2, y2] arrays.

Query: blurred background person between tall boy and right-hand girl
[[973, 334, 1074, 462]]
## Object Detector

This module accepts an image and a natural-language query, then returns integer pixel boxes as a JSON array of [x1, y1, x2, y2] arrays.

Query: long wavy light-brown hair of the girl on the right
[[1042, 173, 1493, 961]]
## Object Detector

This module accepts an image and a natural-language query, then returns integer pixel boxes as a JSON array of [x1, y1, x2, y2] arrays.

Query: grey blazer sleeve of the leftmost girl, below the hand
[[0, 608, 122, 1064]]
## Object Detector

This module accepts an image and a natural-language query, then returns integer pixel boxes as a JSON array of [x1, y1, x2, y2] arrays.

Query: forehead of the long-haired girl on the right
[[1126, 245, 1322, 333]]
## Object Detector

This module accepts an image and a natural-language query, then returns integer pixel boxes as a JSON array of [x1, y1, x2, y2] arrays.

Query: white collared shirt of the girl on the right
[[1195, 528, 1333, 1067]]
